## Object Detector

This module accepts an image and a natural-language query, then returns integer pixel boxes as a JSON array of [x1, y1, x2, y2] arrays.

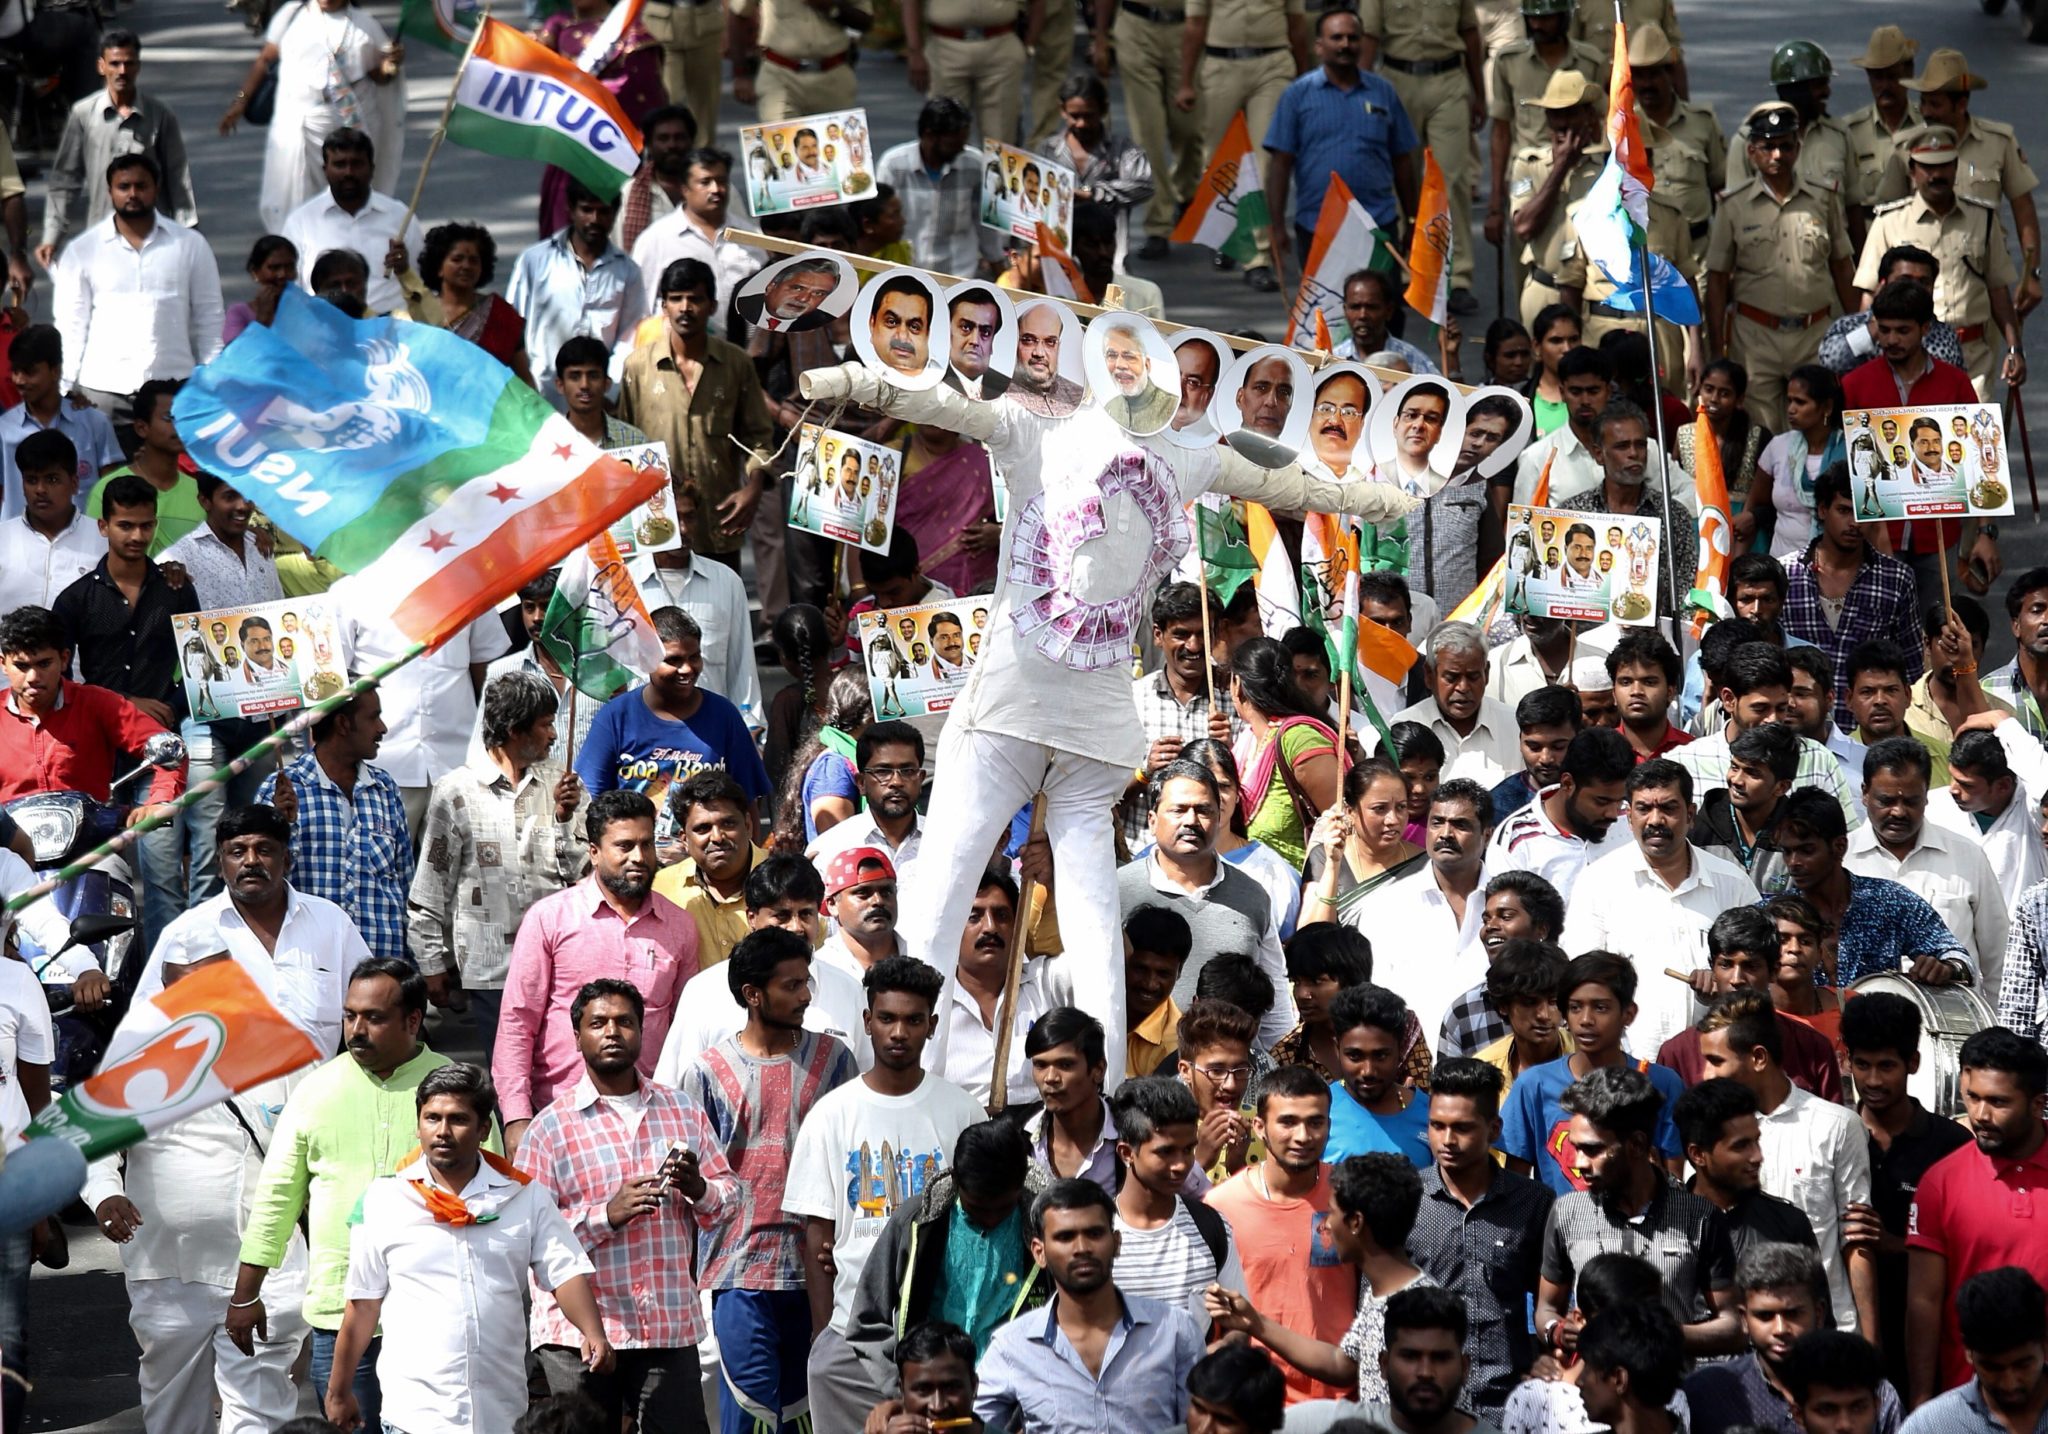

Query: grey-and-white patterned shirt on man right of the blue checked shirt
[[408, 760, 584, 992]]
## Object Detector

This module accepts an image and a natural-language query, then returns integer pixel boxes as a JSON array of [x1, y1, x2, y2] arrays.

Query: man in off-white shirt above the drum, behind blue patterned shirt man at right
[[1841, 737, 1998, 994]]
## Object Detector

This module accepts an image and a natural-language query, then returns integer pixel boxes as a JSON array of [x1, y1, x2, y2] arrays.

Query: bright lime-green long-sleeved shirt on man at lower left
[[242, 1045, 502, 1330]]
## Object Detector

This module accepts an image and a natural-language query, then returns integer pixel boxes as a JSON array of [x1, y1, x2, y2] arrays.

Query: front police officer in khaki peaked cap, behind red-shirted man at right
[[1855, 125, 2025, 397]]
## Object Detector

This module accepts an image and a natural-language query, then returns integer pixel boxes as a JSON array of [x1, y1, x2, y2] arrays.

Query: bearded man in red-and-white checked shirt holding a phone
[[520, 977, 737, 1428]]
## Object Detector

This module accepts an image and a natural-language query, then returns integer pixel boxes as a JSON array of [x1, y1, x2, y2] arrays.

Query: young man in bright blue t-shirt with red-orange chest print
[[1507, 951, 1686, 1194]]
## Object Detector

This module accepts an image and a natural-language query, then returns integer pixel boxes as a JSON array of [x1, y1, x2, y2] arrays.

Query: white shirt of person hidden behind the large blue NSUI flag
[[330, 578, 512, 844]]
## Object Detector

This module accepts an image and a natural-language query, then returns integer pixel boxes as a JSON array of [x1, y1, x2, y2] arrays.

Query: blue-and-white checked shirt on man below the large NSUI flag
[[256, 752, 412, 965]]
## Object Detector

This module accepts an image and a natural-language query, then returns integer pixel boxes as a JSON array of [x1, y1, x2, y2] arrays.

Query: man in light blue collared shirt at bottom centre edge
[[975, 1180, 1202, 1430]]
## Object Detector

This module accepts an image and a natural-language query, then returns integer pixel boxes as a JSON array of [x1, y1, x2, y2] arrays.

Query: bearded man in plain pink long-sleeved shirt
[[492, 791, 696, 1155]]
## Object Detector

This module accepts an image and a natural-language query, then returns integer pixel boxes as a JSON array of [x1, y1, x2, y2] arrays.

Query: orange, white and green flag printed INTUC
[[449, 20, 641, 199]]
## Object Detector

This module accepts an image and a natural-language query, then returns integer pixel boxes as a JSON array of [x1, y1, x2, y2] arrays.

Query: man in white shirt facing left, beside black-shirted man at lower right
[[1694, 989, 1878, 1340]]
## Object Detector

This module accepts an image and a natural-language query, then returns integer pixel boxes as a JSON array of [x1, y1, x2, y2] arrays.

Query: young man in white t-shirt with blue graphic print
[[782, 957, 983, 1430]]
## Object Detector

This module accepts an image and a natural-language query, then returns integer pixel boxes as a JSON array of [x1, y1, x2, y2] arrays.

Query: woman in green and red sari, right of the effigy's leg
[[1231, 637, 1343, 871]]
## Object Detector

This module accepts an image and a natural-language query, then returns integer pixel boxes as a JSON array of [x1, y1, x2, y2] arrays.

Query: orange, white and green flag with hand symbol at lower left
[[29, 961, 319, 1159]]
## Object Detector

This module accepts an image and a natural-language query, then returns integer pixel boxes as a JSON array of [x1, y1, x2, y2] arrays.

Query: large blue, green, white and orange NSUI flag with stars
[[172, 287, 668, 647]]
